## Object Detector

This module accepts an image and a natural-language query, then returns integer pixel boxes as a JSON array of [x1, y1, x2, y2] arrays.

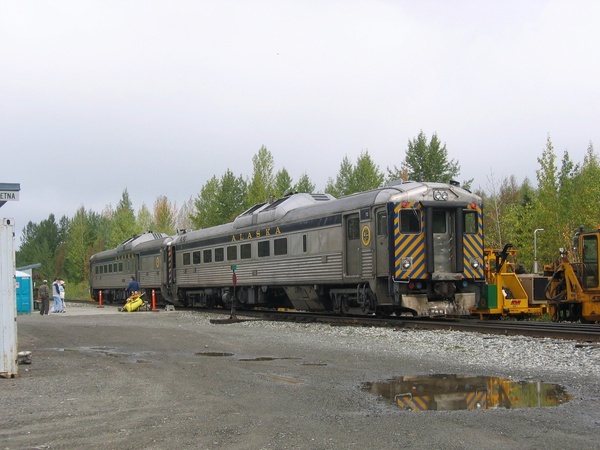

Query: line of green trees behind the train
[[16, 131, 600, 290]]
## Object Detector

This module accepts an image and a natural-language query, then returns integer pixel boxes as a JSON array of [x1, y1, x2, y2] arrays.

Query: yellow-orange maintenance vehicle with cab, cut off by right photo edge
[[544, 226, 600, 323]]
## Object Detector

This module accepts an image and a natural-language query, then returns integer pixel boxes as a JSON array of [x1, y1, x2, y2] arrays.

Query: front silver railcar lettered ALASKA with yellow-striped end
[[162, 182, 485, 315]]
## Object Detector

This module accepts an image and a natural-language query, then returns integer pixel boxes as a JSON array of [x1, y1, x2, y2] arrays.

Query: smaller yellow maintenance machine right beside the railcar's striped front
[[470, 244, 547, 319]]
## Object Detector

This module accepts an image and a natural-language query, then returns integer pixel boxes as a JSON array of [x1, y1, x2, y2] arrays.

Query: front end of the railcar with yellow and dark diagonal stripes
[[388, 184, 485, 316]]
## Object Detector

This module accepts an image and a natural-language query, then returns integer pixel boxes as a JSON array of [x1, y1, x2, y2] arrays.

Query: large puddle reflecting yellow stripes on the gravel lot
[[362, 375, 573, 411]]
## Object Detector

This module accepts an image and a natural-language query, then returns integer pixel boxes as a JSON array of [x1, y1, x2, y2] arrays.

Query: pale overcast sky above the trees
[[0, 0, 600, 246]]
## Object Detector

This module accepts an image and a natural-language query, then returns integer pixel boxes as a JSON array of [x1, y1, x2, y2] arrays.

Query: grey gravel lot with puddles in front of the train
[[0, 304, 600, 449]]
